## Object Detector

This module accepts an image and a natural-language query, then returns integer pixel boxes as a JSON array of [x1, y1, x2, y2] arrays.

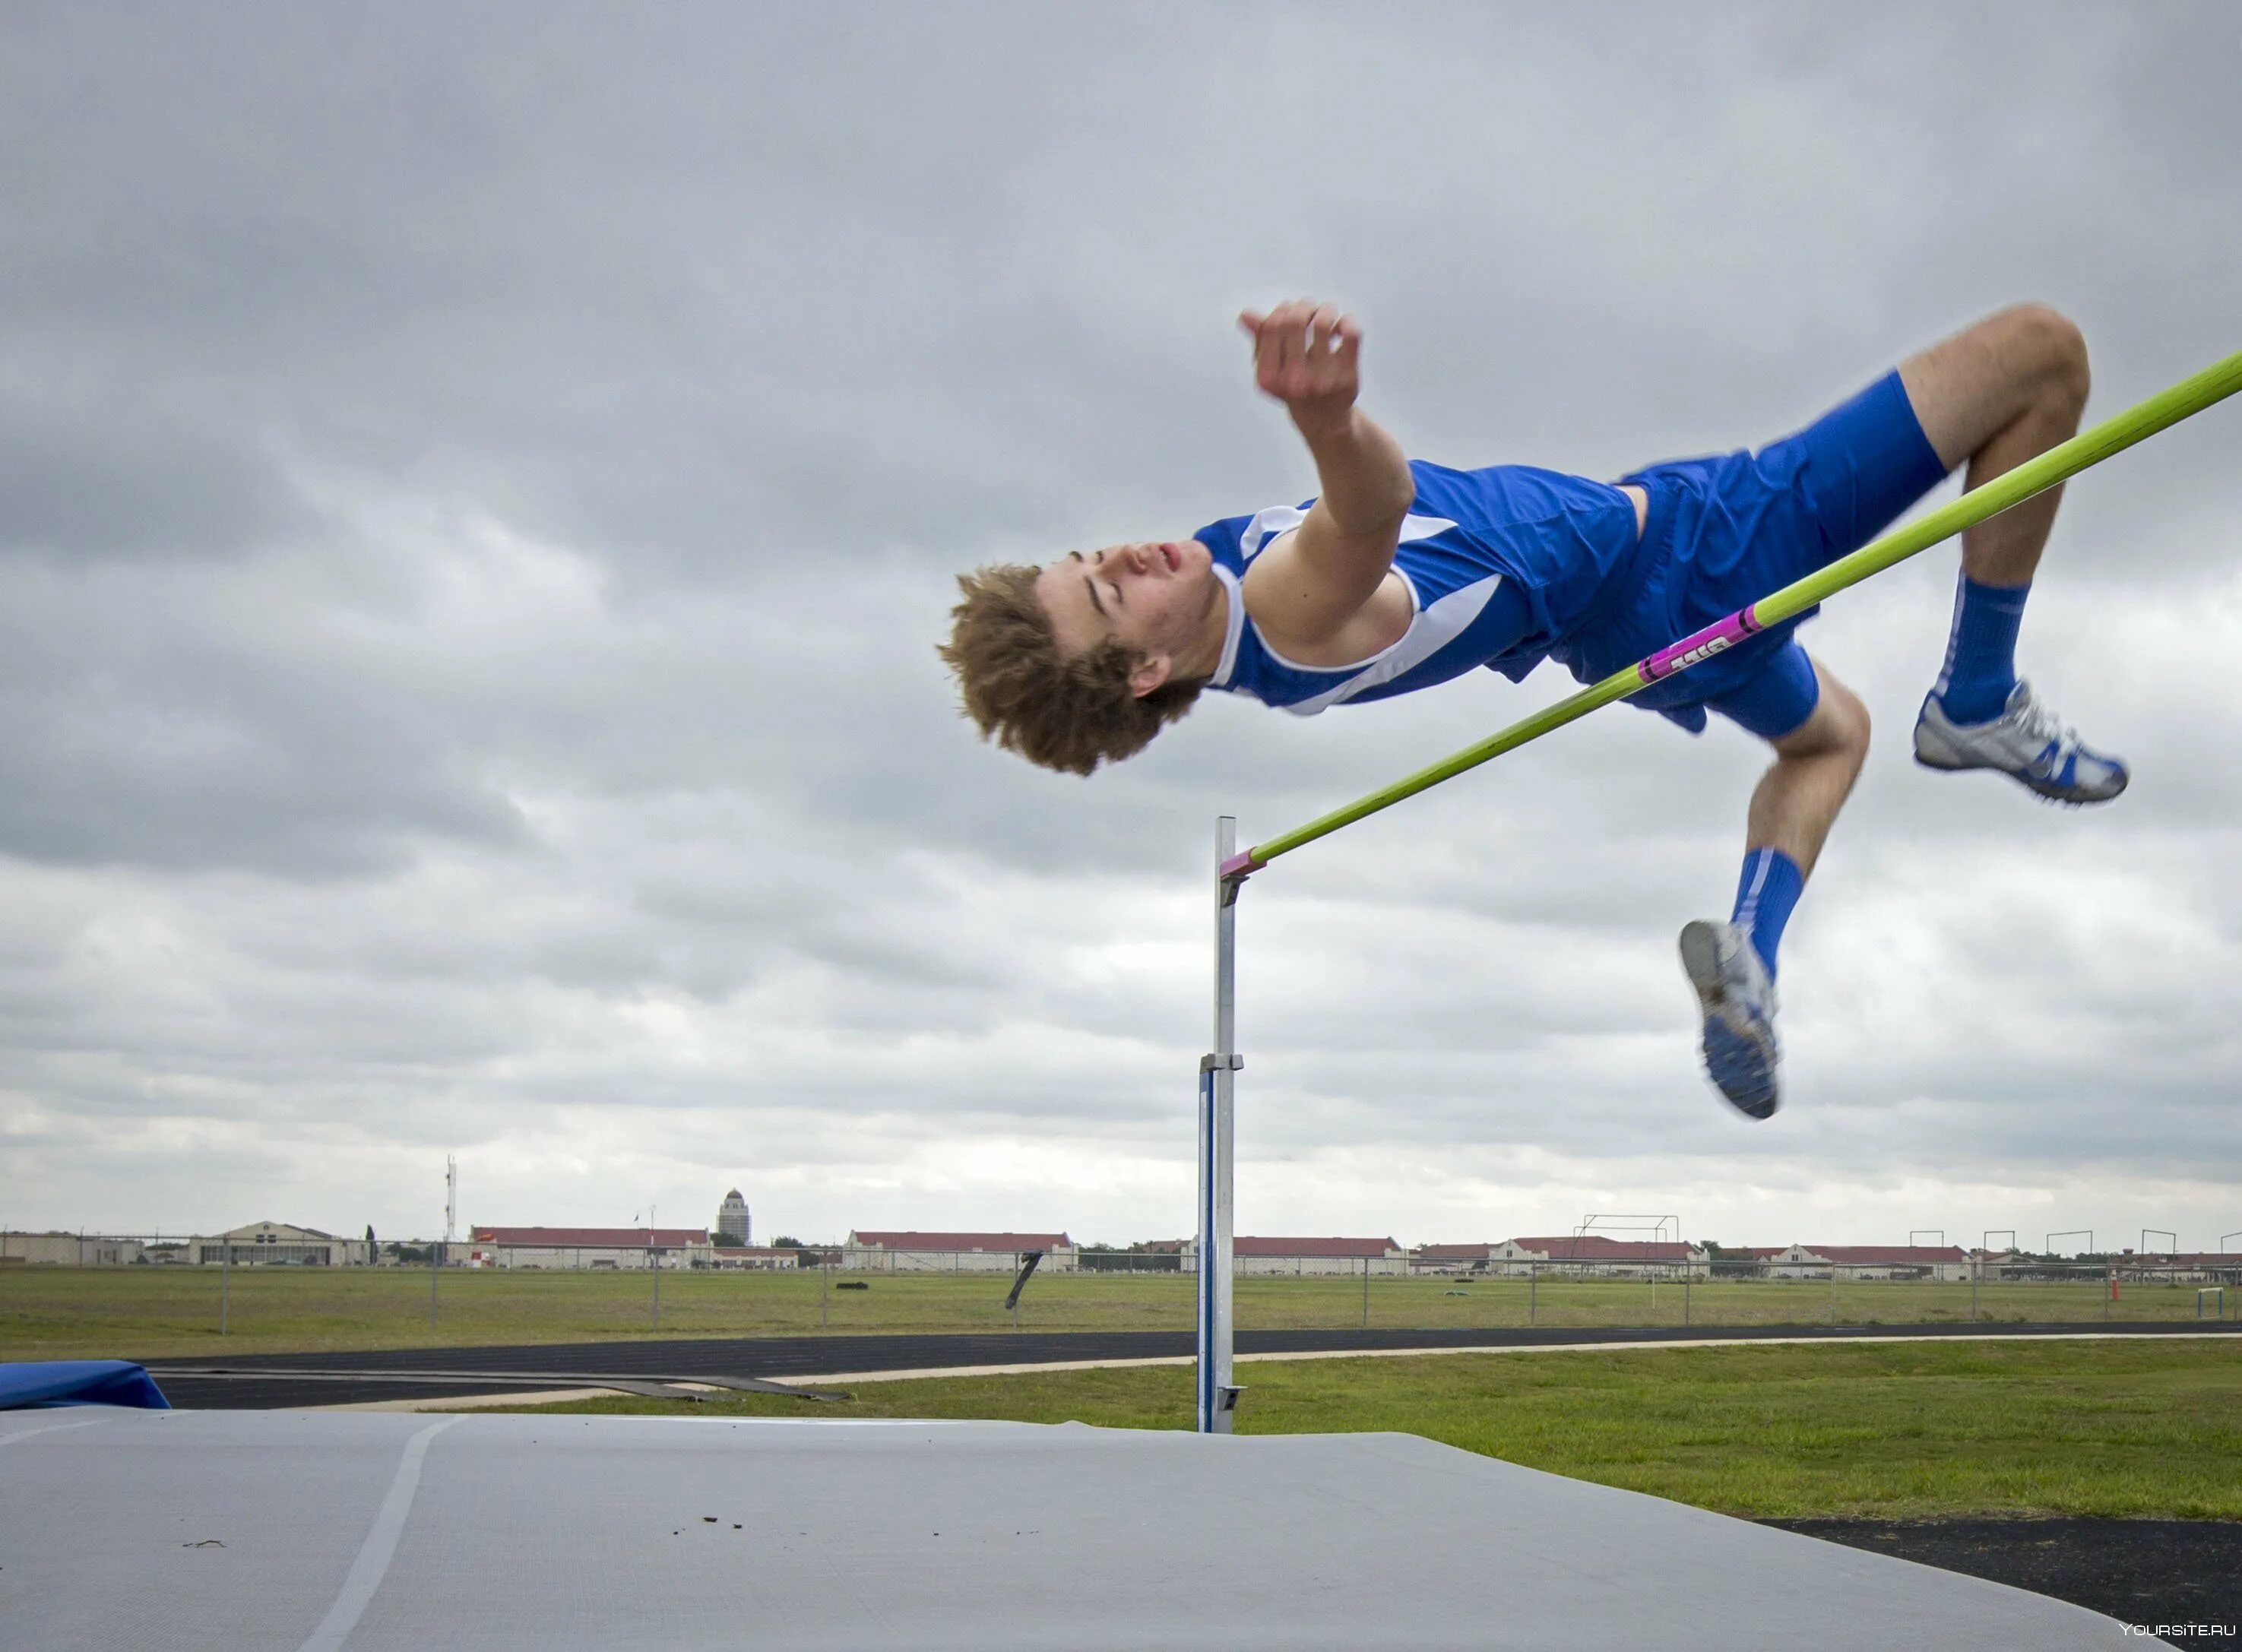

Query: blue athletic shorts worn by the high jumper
[[1565, 372, 1946, 737]]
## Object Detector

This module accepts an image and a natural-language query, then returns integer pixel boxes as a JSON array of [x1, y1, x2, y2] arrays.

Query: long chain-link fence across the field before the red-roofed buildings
[[0, 1235, 2242, 1359]]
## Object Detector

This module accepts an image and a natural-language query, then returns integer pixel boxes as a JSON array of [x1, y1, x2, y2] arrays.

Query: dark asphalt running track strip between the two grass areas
[[144, 1320, 2242, 1410]]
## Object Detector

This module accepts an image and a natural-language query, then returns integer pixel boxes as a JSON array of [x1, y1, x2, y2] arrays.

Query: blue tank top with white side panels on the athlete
[[1195, 460, 1637, 717]]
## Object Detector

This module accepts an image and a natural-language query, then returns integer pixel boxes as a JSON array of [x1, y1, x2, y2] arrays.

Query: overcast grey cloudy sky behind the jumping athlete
[[0, 0, 2242, 1248]]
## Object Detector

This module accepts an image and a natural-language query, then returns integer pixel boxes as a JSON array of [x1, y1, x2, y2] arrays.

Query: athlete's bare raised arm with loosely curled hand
[[1237, 300, 1417, 646]]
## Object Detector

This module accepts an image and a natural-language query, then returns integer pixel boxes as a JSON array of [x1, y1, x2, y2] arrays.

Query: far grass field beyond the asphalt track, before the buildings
[[0, 1267, 2224, 1359]]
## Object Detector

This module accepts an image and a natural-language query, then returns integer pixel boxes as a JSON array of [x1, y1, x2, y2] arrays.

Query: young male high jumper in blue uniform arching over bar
[[942, 298, 2126, 1119]]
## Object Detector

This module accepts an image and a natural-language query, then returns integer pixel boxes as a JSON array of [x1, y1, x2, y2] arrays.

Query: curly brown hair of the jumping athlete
[[935, 562, 1204, 774]]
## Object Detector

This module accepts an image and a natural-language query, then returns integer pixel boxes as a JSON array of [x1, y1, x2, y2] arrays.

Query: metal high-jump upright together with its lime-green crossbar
[[1197, 354, 2242, 1435]]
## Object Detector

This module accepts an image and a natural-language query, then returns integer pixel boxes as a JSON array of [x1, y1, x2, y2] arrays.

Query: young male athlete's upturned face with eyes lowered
[[1036, 540, 1222, 695]]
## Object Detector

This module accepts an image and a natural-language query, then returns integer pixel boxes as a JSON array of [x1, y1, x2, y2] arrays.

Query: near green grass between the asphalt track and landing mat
[[482, 1338, 2242, 1542]]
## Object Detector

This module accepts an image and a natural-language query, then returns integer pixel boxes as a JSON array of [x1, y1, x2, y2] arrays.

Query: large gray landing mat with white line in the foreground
[[0, 1410, 2157, 1652]]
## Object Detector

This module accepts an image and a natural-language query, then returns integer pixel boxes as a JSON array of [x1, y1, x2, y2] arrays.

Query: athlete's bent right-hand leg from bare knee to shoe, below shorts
[[1899, 305, 2128, 802]]
